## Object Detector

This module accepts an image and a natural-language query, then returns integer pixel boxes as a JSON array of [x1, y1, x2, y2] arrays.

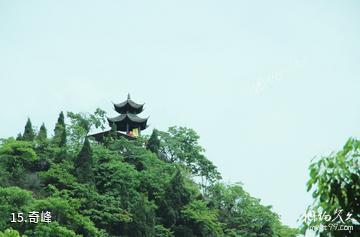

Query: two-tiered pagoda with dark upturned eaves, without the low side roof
[[107, 94, 148, 137]]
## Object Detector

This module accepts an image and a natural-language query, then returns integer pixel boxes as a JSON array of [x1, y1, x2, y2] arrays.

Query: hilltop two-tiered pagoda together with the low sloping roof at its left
[[90, 94, 148, 142]]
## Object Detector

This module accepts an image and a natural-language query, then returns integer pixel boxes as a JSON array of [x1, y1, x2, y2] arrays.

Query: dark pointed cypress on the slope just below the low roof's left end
[[75, 137, 93, 183]]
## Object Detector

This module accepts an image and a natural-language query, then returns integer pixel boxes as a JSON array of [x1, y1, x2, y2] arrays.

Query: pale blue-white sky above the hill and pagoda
[[0, 0, 360, 233]]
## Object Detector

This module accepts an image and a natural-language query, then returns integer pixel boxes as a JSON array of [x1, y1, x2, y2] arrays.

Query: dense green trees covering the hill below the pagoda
[[0, 110, 296, 237]]
